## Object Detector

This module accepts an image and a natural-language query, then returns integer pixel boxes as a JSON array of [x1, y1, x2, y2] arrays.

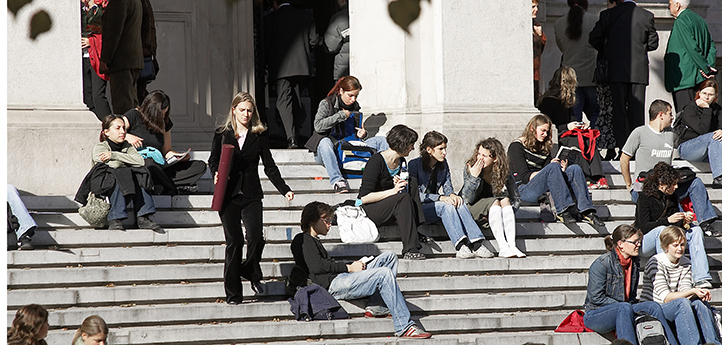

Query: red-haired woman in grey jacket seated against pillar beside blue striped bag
[[306, 76, 389, 193]]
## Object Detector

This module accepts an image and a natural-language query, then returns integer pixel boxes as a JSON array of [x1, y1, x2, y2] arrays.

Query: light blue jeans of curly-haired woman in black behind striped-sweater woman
[[639, 225, 712, 283]]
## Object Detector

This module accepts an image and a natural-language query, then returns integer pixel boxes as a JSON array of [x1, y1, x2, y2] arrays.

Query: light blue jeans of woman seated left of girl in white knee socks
[[421, 201, 484, 246]]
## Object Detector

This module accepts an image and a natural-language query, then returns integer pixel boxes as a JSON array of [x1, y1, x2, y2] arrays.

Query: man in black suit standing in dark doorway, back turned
[[264, 0, 320, 148]]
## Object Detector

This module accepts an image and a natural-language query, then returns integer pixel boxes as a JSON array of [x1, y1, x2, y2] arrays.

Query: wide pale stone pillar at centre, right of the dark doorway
[[350, 0, 537, 185]]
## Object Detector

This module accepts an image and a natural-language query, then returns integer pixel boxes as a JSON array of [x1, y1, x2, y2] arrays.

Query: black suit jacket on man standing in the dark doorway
[[264, 5, 320, 81]]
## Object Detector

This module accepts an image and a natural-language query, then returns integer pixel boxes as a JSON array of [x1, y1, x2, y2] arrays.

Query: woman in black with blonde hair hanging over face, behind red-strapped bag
[[537, 66, 609, 189]]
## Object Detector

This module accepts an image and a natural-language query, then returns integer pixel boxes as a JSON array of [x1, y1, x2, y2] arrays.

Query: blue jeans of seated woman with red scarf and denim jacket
[[584, 301, 678, 345]]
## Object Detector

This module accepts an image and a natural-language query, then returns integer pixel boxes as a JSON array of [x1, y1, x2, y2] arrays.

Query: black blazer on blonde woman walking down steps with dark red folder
[[208, 130, 291, 207]]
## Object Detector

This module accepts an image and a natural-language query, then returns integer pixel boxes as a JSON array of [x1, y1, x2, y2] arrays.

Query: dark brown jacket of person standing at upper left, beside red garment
[[100, 0, 143, 73]]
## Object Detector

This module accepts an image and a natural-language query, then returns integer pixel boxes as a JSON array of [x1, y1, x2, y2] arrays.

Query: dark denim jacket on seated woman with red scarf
[[584, 250, 639, 310]]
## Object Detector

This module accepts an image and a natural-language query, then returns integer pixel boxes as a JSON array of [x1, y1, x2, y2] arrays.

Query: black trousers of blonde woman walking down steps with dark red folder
[[218, 195, 266, 302]]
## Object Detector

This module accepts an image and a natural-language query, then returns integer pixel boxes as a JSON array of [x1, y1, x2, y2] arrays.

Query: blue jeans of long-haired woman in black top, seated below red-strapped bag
[[519, 163, 594, 213]]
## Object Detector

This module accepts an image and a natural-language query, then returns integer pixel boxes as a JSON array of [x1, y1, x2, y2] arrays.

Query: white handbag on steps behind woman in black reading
[[336, 206, 379, 243]]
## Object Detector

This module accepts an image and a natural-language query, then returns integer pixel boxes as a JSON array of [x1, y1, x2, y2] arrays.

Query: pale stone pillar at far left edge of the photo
[[7, 0, 101, 195]]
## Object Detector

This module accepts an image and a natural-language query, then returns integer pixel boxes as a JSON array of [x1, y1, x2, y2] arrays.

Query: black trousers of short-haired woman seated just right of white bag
[[362, 192, 421, 254]]
